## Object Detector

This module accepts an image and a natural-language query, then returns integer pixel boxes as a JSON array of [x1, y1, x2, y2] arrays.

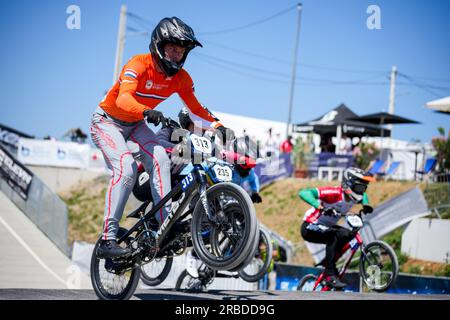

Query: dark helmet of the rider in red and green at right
[[341, 167, 374, 203]]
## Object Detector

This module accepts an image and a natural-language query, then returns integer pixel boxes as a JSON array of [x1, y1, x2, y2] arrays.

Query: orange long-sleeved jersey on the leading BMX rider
[[100, 53, 220, 128]]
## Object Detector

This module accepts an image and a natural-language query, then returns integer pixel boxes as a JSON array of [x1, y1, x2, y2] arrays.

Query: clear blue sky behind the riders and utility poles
[[0, 0, 450, 142]]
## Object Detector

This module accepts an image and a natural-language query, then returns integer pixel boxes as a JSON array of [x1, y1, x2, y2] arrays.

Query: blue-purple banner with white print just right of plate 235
[[255, 153, 294, 187]]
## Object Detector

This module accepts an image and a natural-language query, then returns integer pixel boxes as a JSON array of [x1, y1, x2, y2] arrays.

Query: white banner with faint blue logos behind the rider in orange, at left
[[17, 138, 91, 168]]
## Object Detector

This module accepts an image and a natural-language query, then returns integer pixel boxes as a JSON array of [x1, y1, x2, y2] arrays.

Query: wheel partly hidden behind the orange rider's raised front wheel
[[239, 229, 273, 282]]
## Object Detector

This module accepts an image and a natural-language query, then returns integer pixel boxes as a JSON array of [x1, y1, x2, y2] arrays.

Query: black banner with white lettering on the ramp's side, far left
[[0, 145, 33, 200]]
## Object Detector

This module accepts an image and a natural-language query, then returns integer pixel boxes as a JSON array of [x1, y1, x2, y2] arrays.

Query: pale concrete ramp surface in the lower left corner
[[0, 191, 92, 289]]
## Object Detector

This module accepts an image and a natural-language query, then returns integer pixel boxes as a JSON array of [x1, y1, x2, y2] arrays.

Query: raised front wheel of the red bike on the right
[[359, 240, 398, 292]]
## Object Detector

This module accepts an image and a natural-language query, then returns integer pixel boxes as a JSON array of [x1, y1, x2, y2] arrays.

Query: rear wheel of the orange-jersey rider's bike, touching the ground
[[91, 228, 140, 300]]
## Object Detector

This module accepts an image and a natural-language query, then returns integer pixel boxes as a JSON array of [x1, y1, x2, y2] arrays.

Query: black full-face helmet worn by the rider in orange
[[149, 17, 203, 77]]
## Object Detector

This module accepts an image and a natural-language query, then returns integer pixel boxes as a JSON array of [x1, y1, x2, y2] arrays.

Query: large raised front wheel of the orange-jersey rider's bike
[[191, 183, 259, 270]]
